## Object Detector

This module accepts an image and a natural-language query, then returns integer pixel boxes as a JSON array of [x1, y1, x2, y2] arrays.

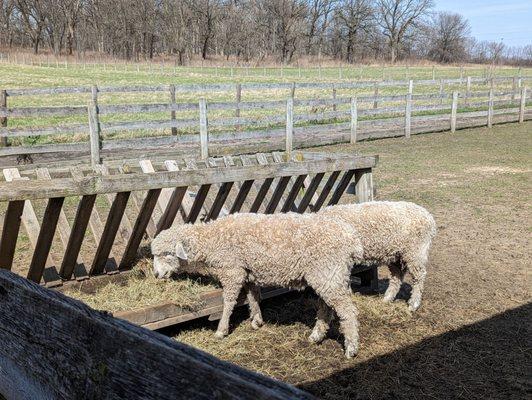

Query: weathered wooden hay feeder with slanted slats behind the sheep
[[0, 152, 377, 329]]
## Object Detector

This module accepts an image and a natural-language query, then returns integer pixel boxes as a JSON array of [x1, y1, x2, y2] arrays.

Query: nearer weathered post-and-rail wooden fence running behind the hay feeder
[[0, 84, 527, 166]]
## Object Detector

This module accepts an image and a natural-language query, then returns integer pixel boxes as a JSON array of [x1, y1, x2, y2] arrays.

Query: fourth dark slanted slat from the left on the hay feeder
[[89, 192, 131, 275]]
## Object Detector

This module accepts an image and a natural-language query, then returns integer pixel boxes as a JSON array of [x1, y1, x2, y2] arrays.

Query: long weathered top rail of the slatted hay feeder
[[0, 156, 377, 201]]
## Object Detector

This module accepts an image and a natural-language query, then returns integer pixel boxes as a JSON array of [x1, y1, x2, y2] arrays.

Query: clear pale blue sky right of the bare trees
[[435, 0, 532, 46]]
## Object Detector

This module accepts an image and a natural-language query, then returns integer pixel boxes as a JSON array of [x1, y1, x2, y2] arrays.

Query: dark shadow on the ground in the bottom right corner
[[300, 303, 532, 400]]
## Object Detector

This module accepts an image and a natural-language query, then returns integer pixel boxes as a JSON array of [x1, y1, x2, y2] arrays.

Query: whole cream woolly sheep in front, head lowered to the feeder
[[151, 213, 362, 358]]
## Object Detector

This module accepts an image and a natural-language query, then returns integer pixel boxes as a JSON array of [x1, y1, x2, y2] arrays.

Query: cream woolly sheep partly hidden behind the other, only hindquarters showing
[[319, 201, 436, 312]]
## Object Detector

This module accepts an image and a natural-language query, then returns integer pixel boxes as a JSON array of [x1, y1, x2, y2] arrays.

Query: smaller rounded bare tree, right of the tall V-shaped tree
[[427, 12, 470, 63]]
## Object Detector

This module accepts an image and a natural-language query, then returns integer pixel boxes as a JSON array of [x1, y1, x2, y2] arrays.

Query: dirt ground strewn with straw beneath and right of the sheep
[[164, 122, 532, 399]]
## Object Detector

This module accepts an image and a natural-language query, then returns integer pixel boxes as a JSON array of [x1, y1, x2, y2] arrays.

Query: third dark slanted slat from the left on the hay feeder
[[59, 194, 96, 280]]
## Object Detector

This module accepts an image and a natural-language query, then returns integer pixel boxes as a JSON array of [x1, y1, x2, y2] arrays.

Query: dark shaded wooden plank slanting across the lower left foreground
[[0, 271, 313, 400]]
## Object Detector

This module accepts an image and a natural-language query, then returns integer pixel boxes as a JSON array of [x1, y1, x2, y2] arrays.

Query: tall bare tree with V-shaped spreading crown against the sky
[[377, 0, 433, 63]]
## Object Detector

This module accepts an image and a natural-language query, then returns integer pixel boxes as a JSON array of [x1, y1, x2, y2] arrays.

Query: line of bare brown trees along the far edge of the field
[[0, 0, 532, 64]]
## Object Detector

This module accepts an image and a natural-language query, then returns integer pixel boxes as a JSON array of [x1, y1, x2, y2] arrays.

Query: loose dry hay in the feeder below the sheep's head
[[65, 259, 218, 312]]
